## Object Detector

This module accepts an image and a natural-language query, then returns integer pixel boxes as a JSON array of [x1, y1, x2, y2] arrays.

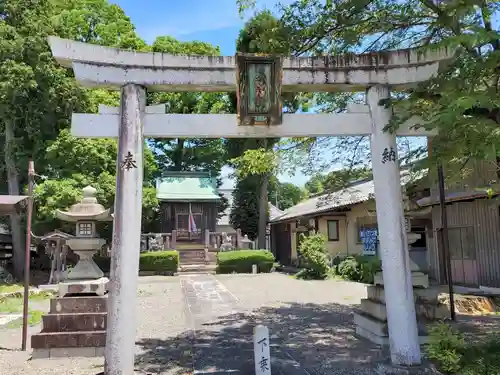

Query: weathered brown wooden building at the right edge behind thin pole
[[418, 161, 500, 288]]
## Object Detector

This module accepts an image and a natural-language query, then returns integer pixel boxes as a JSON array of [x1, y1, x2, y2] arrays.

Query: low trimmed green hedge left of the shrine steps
[[93, 250, 179, 272]]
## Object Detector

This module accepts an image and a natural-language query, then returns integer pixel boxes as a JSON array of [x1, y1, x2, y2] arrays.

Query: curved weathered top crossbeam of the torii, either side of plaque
[[49, 37, 453, 92]]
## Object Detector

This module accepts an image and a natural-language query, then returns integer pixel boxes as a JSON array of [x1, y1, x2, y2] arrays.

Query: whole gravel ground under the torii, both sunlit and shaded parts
[[0, 274, 384, 375]]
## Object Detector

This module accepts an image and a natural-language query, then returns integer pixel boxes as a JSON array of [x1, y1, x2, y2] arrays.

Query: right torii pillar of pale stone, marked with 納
[[366, 85, 421, 366]]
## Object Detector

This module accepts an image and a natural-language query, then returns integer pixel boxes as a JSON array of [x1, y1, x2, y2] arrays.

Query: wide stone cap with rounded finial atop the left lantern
[[57, 186, 113, 222]]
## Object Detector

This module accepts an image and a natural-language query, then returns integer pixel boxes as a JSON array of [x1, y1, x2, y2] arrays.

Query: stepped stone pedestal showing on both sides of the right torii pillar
[[354, 285, 448, 345]]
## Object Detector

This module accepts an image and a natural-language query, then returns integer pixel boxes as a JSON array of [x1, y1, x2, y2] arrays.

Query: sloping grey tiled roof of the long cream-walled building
[[271, 170, 427, 222]]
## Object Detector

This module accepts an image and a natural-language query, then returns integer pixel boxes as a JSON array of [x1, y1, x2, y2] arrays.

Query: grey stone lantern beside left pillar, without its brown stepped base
[[57, 186, 113, 295]]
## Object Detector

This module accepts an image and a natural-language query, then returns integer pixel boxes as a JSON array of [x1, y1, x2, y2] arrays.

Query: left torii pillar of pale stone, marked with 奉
[[104, 84, 146, 375]]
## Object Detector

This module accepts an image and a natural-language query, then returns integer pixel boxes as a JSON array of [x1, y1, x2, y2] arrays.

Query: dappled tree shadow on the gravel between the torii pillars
[[136, 303, 384, 374]]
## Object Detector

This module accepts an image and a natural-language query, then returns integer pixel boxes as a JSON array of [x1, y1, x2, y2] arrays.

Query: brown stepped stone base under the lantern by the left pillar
[[31, 277, 109, 358]]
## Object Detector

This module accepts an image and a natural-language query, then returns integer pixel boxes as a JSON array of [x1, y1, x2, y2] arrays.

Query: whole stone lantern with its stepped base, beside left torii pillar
[[31, 186, 113, 358]]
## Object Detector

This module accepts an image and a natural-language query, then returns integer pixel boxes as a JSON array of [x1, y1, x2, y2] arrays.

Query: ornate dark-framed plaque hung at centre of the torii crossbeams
[[236, 53, 283, 125]]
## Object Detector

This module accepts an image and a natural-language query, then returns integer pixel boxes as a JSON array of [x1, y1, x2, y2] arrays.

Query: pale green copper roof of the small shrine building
[[156, 172, 220, 201]]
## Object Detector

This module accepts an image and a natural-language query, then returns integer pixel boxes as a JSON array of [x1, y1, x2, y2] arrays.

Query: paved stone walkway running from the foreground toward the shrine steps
[[180, 275, 309, 375]]
